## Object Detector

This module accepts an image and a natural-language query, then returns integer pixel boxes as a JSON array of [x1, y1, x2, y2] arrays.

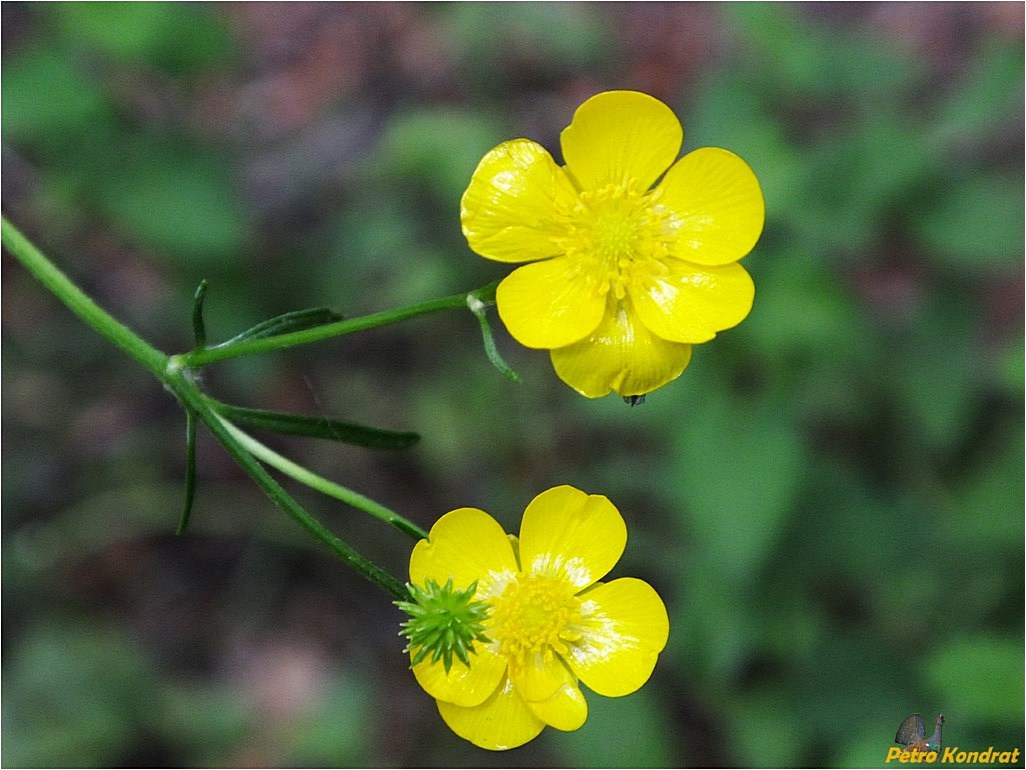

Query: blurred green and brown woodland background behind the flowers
[[2, 3, 1024, 767]]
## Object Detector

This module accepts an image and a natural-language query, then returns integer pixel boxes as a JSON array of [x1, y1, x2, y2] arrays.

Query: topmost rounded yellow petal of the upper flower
[[559, 91, 684, 191]]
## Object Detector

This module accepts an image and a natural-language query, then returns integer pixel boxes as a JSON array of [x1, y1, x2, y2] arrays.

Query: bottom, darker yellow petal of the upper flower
[[550, 301, 692, 398]]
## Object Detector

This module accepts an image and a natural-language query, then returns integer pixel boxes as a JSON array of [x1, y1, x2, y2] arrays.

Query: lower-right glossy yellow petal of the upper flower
[[629, 259, 755, 343]]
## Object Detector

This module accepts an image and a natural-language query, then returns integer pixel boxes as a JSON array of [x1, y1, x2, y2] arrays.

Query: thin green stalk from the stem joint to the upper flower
[[173, 283, 498, 369]]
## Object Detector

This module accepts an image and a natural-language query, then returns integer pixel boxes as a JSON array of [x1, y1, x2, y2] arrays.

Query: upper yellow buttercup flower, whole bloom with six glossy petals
[[461, 91, 764, 398]]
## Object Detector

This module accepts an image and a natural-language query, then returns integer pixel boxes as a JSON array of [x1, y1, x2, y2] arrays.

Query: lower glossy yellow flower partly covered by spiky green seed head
[[409, 486, 669, 749]]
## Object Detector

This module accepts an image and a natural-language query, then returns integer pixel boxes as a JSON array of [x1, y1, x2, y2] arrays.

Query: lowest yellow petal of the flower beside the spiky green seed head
[[437, 680, 545, 750]]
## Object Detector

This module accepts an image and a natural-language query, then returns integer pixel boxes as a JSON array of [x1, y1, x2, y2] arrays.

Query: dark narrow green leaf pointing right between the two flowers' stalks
[[215, 402, 421, 450]]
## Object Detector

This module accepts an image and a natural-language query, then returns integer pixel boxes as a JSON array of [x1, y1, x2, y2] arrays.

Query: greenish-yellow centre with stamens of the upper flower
[[563, 180, 668, 300]]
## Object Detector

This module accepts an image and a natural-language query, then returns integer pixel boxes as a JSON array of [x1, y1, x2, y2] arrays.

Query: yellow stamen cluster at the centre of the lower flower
[[488, 575, 581, 662]]
